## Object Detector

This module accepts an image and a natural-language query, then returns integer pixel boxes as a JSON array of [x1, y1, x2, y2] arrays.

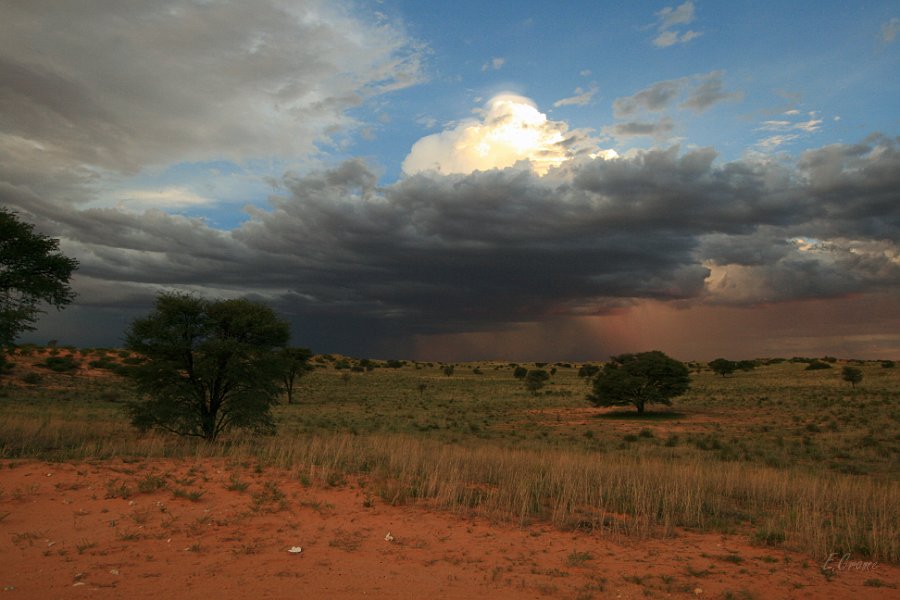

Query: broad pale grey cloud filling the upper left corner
[[0, 0, 423, 173]]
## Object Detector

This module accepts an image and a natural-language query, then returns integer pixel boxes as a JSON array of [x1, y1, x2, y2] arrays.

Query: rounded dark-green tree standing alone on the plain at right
[[588, 350, 691, 413]]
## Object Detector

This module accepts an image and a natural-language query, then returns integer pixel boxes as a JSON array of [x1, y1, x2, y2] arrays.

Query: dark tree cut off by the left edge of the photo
[[0, 208, 78, 375]]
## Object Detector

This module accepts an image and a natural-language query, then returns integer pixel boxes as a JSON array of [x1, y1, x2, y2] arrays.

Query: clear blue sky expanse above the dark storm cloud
[[107, 1, 900, 229]]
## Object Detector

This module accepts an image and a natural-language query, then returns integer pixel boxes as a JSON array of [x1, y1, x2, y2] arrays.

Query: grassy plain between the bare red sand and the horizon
[[0, 349, 900, 563]]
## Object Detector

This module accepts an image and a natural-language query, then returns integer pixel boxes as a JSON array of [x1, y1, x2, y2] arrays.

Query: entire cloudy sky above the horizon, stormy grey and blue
[[0, 0, 900, 361]]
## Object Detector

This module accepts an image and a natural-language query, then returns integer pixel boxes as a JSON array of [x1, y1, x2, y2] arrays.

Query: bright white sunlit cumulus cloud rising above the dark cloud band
[[403, 94, 617, 175]]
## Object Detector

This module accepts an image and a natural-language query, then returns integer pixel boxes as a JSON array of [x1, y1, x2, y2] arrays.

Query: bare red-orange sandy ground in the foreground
[[0, 460, 900, 600]]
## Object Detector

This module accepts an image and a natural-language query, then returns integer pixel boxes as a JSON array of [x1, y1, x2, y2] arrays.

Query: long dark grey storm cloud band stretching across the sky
[[8, 137, 900, 355]]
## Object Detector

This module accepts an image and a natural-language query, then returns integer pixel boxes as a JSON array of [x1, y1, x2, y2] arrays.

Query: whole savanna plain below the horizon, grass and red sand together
[[0, 346, 900, 599]]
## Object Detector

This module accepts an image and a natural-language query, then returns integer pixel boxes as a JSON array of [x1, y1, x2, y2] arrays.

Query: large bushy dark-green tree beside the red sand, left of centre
[[126, 293, 290, 441]]
